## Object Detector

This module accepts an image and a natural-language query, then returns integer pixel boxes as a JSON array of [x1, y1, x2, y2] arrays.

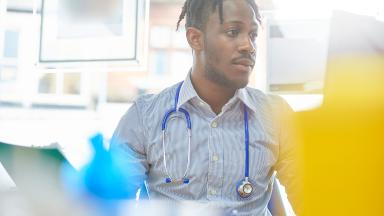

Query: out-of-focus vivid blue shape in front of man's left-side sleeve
[[63, 133, 147, 202]]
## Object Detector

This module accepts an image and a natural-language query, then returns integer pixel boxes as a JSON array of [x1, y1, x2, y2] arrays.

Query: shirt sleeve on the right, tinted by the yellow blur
[[275, 99, 300, 214]]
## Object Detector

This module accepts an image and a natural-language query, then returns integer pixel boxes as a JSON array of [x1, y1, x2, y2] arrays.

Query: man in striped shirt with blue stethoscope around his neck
[[111, 0, 295, 215]]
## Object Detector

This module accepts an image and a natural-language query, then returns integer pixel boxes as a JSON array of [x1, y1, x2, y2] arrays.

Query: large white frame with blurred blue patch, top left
[[39, 0, 149, 68]]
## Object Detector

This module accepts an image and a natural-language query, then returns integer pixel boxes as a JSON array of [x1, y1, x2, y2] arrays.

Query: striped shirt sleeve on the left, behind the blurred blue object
[[110, 102, 149, 183]]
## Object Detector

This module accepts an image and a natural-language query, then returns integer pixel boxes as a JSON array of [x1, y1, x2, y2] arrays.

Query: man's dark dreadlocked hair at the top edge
[[176, 0, 261, 31]]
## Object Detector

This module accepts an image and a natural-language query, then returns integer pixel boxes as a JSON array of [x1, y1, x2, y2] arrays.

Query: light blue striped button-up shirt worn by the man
[[111, 75, 296, 215]]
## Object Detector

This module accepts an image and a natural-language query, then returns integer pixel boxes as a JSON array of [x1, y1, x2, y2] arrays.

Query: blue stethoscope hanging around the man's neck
[[161, 82, 253, 198]]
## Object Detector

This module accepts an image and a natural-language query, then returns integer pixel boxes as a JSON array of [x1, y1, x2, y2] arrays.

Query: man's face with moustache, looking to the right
[[204, 0, 258, 89]]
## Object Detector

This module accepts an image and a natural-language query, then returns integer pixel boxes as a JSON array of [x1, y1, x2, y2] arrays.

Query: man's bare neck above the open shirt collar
[[191, 69, 236, 114]]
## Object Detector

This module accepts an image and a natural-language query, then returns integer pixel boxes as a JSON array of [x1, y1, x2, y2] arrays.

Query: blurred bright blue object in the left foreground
[[62, 133, 145, 216]]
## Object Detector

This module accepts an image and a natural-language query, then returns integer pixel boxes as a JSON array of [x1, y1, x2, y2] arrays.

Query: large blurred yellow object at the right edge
[[296, 54, 384, 216]]
